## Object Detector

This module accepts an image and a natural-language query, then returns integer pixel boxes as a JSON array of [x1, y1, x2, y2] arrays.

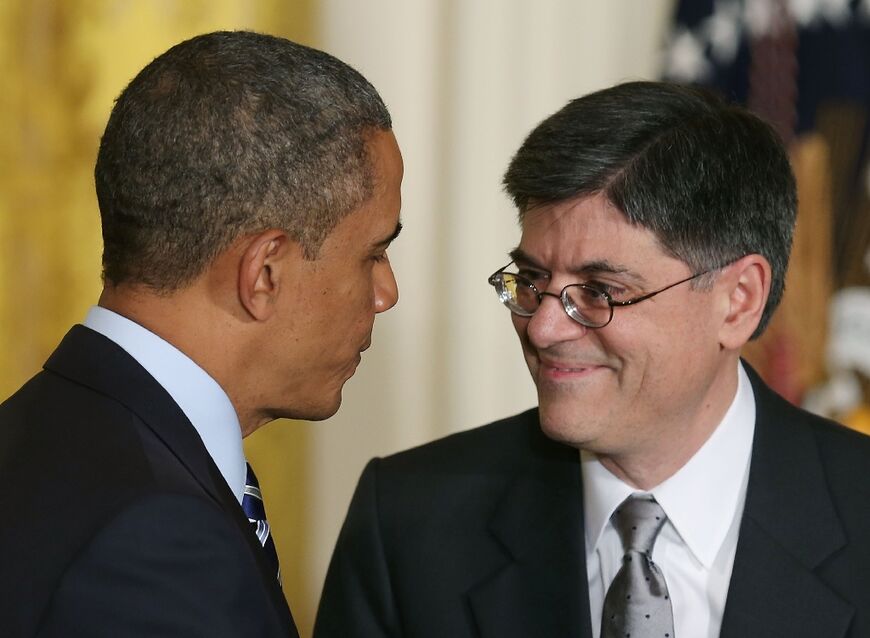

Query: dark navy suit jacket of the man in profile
[[0, 326, 297, 638]]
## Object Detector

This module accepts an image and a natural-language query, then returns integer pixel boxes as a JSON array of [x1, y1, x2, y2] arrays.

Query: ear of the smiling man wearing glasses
[[715, 255, 771, 350]]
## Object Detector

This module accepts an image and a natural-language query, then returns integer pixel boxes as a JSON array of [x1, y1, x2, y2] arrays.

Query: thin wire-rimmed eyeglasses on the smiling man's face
[[488, 262, 731, 328]]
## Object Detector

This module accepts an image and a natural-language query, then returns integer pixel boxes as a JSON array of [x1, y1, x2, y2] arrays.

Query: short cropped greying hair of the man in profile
[[94, 31, 391, 292]]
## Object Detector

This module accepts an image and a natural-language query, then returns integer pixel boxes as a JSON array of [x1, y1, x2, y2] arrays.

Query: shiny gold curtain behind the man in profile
[[0, 0, 316, 635]]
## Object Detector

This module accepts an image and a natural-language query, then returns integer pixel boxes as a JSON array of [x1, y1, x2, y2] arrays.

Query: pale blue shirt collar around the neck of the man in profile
[[84, 306, 246, 503]]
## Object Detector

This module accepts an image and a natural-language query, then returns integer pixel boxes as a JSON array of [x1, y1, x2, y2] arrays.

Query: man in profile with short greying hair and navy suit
[[0, 32, 402, 638]]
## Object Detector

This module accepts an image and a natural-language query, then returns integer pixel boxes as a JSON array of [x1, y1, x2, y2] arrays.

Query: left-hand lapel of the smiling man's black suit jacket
[[469, 422, 591, 638]]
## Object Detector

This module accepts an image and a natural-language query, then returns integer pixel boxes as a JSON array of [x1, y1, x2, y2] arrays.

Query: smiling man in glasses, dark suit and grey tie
[[315, 82, 870, 638]]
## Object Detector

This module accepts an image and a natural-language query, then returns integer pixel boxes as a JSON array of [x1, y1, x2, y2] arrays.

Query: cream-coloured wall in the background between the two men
[[308, 0, 672, 632]]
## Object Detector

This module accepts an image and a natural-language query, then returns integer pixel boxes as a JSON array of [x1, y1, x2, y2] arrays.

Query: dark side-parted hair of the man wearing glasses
[[504, 82, 797, 338]]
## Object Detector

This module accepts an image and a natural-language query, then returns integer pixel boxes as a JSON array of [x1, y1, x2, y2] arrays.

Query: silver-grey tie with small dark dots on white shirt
[[601, 496, 674, 638]]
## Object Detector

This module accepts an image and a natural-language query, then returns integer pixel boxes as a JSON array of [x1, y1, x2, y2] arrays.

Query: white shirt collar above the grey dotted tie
[[581, 364, 755, 568]]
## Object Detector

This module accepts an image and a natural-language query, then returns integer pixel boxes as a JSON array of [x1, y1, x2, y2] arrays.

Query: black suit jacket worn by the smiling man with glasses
[[314, 372, 870, 638]]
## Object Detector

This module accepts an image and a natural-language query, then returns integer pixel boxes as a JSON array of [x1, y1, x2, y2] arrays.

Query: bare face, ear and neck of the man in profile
[[100, 131, 403, 436]]
